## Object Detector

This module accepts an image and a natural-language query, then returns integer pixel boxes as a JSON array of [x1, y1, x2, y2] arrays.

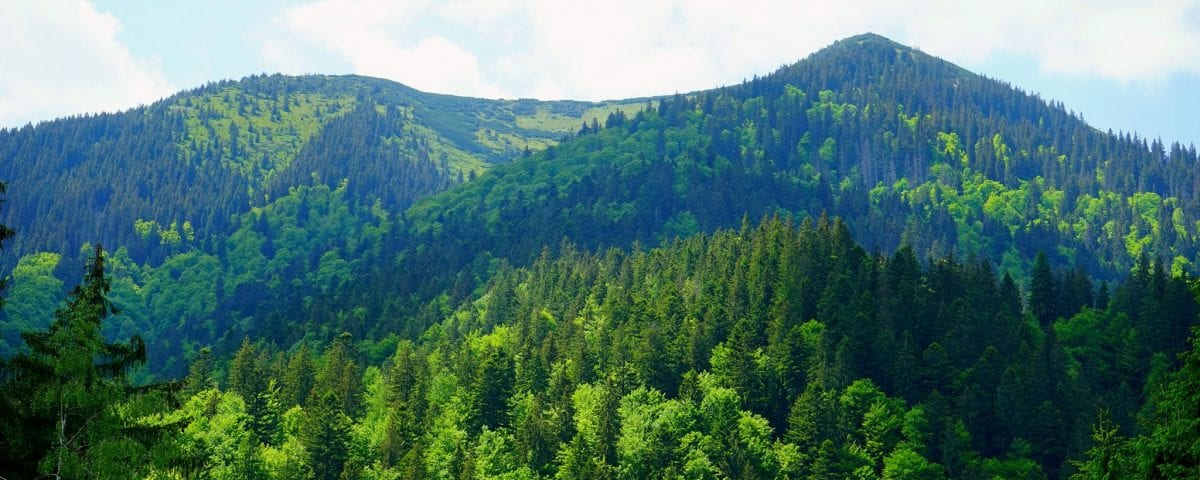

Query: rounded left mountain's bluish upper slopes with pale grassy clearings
[[0, 76, 648, 266]]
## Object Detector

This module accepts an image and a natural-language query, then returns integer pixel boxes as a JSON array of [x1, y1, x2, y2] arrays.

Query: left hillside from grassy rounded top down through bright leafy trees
[[0, 76, 641, 360]]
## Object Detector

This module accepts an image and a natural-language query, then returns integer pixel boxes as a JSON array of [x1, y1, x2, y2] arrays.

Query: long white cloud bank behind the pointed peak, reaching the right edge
[[262, 0, 1200, 100]]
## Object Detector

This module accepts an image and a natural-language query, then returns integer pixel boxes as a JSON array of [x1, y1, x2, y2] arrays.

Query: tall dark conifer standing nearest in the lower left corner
[[0, 245, 146, 478]]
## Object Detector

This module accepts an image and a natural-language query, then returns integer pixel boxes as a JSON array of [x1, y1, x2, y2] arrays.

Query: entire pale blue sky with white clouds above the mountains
[[0, 0, 1200, 145]]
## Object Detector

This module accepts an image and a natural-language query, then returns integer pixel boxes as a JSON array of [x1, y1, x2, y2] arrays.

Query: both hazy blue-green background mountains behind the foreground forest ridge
[[0, 35, 1200, 370]]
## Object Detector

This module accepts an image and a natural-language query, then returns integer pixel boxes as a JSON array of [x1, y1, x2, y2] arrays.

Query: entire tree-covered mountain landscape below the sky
[[0, 35, 1200, 479]]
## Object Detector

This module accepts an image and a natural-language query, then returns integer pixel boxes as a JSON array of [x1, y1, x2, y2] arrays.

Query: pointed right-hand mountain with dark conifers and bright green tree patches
[[381, 35, 1200, 300]]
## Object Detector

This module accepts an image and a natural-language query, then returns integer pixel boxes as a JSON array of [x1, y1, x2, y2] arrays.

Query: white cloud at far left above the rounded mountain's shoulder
[[0, 0, 175, 126]]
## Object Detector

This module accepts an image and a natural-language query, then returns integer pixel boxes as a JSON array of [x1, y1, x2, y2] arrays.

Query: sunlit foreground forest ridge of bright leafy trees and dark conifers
[[2, 218, 1200, 479]]
